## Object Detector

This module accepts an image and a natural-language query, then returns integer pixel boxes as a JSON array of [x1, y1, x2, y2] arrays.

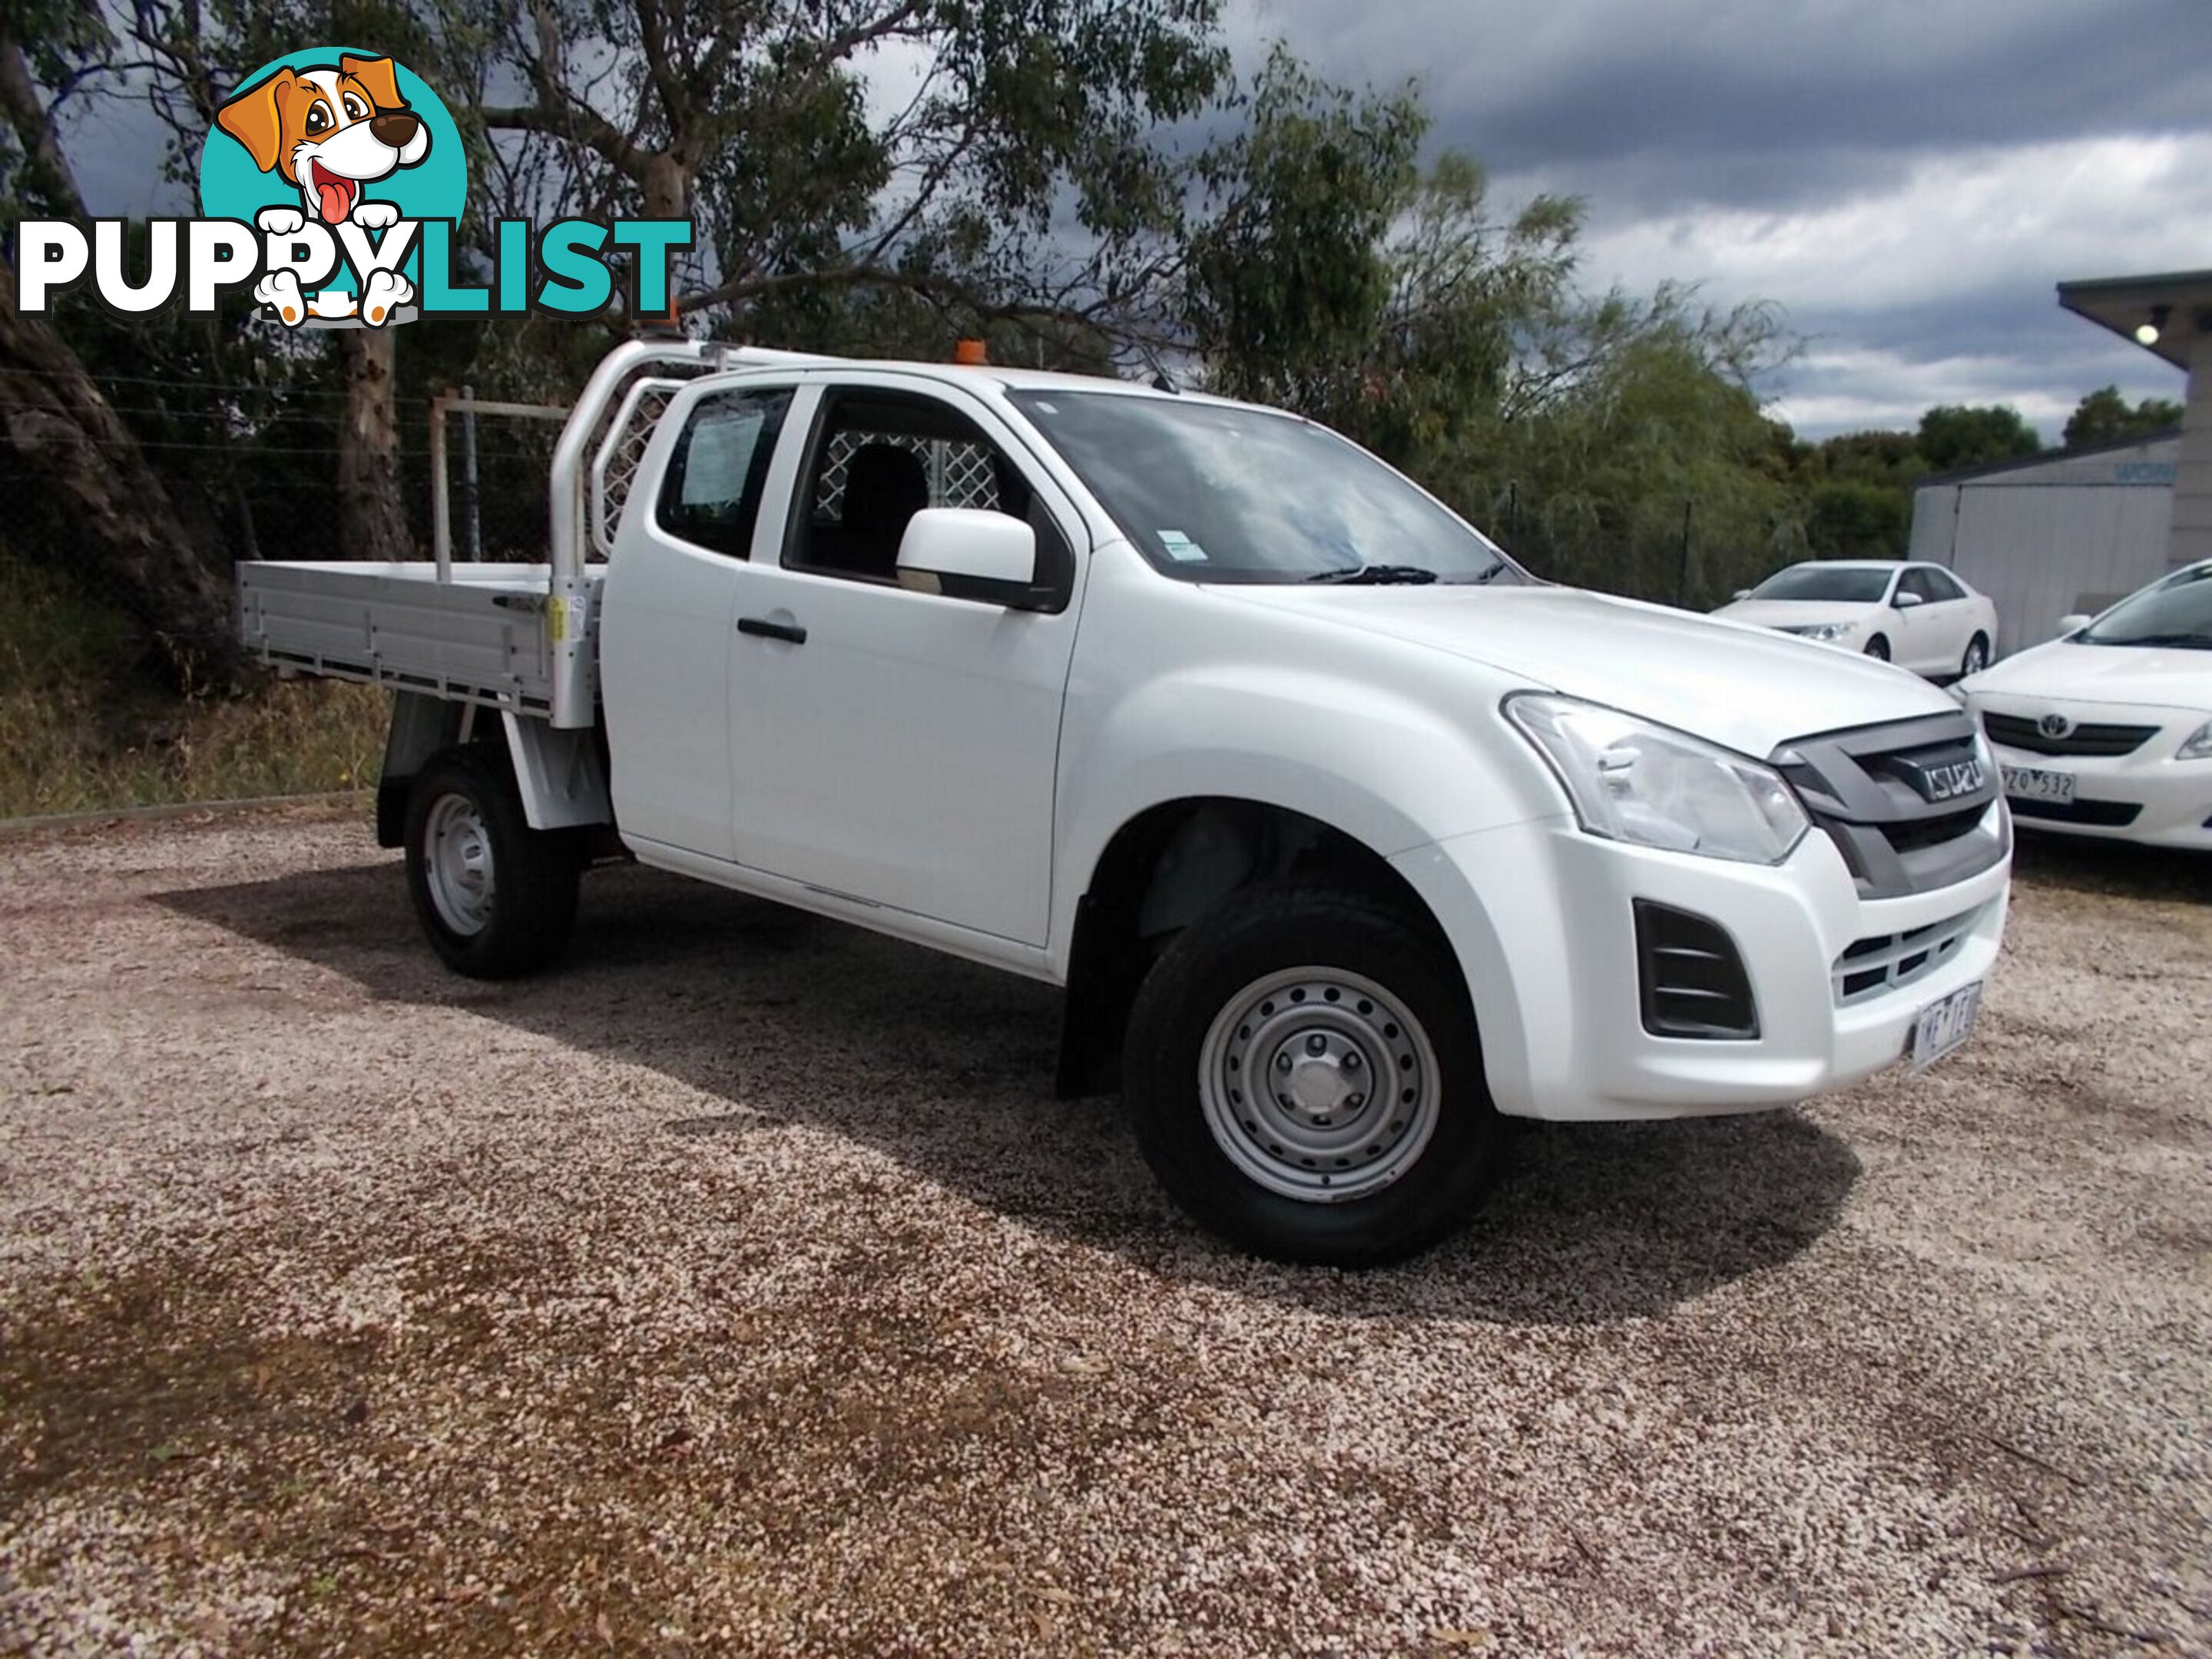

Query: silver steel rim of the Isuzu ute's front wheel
[[1199, 967, 1442, 1204]]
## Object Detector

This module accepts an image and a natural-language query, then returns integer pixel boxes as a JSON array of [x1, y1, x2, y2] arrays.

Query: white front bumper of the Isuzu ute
[[1392, 805, 2011, 1119]]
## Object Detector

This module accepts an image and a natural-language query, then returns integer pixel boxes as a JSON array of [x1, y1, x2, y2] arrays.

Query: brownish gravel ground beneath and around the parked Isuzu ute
[[0, 810, 2212, 1654]]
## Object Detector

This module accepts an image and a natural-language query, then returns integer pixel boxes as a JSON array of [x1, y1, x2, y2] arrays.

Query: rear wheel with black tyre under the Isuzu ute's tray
[[407, 747, 584, 980]]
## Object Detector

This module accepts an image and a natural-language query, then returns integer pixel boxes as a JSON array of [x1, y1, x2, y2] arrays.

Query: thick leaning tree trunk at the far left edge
[[0, 257, 246, 690]]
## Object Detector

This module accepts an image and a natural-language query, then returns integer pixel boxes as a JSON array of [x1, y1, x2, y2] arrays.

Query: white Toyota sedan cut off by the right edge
[[1960, 560, 2212, 852]]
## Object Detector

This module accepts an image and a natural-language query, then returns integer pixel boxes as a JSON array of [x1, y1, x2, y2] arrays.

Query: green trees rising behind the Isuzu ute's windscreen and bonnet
[[1188, 71, 1803, 599]]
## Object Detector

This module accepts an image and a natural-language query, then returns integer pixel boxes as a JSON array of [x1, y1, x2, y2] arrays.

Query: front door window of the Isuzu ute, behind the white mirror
[[783, 389, 1075, 611]]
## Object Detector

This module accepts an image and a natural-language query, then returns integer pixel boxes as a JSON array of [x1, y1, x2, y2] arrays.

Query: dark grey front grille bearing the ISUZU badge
[[1770, 710, 2006, 898]]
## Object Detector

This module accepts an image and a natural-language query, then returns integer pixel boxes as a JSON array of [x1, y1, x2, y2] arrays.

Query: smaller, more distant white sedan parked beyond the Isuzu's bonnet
[[1714, 560, 1998, 679]]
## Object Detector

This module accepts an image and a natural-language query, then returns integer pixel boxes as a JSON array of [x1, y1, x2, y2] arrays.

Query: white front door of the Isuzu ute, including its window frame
[[730, 372, 1081, 945]]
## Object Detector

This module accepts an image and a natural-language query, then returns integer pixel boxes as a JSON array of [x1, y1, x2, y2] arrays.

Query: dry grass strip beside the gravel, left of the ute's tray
[[0, 558, 389, 819]]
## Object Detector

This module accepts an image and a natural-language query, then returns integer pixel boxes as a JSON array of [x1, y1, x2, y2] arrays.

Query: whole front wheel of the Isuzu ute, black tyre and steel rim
[[1121, 882, 1502, 1267]]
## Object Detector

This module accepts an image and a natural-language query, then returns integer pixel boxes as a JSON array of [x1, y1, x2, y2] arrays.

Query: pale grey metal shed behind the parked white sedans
[[1911, 433, 2181, 654]]
